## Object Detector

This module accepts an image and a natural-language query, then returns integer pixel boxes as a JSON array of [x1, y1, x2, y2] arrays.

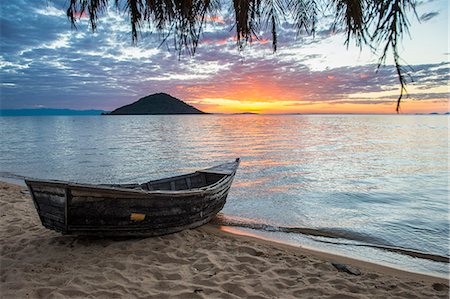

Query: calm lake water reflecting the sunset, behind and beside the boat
[[0, 115, 450, 276]]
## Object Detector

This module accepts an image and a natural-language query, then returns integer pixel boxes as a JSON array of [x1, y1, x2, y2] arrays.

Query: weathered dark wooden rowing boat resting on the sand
[[25, 158, 239, 236]]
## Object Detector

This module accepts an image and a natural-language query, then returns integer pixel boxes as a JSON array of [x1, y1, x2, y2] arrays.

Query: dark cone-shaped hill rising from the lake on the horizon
[[107, 93, 205, 115]]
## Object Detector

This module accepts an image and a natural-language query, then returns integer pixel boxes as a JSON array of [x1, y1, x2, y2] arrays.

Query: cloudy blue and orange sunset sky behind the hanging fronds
[[0, 0, 450, 113]]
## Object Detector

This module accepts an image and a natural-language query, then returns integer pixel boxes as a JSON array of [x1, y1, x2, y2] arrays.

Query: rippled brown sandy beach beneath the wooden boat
[[0, 183, 449, 298]]
